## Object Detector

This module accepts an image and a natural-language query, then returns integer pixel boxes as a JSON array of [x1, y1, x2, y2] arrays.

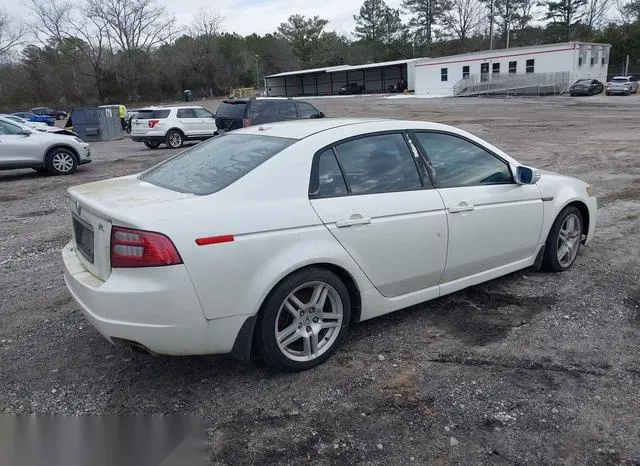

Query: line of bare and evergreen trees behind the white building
[[0, 0, 640, 111]]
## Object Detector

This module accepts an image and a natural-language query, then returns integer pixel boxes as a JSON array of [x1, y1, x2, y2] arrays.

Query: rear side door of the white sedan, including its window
[[310, 133, 447, 297]]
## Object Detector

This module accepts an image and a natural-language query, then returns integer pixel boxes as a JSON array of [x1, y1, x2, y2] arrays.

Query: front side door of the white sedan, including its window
[[413, 132, 543, 284]]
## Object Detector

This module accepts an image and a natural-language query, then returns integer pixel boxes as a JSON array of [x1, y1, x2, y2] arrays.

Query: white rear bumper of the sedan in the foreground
[[62, 242, 249, 355]]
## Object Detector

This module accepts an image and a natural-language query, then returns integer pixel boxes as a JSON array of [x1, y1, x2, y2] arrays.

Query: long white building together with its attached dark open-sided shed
[[265, 42, 611, 96]]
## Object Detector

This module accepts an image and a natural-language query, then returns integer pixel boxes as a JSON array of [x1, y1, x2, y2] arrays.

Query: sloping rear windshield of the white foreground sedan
[[140, 134, 295, 196]]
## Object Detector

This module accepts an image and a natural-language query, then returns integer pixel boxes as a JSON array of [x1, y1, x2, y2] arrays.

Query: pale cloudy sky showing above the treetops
[[5, 0, 402, 35]]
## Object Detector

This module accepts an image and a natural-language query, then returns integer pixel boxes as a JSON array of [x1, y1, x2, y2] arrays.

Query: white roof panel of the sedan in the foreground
[[230, 118, 468, 139]]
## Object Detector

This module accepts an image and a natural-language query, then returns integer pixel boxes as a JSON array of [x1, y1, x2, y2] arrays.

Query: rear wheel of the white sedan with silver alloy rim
[[256, 268, 351, 372]]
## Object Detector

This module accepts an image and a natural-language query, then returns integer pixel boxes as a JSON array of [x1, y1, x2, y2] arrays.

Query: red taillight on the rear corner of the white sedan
[[111, 227, 182, 267]]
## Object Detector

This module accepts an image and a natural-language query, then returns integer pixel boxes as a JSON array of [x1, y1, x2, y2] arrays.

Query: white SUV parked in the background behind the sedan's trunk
[[131, 105, 218, 149]]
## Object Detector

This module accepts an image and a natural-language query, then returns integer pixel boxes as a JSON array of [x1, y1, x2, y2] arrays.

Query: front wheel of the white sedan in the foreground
[[542, 206, 582, 272]]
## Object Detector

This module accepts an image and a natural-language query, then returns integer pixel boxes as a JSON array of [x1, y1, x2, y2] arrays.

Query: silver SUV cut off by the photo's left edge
[[0, 117, 91, 175]]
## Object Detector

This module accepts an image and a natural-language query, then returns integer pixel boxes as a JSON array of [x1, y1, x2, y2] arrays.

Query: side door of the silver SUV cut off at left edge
[[0, 121, 44, 166]]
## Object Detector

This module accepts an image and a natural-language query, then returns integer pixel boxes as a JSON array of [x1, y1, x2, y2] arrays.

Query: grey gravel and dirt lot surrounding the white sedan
[[0, 96, 640, 465]]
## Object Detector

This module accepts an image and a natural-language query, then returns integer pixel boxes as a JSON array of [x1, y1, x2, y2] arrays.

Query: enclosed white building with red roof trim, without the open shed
[[409, 42, 611, 95]]
